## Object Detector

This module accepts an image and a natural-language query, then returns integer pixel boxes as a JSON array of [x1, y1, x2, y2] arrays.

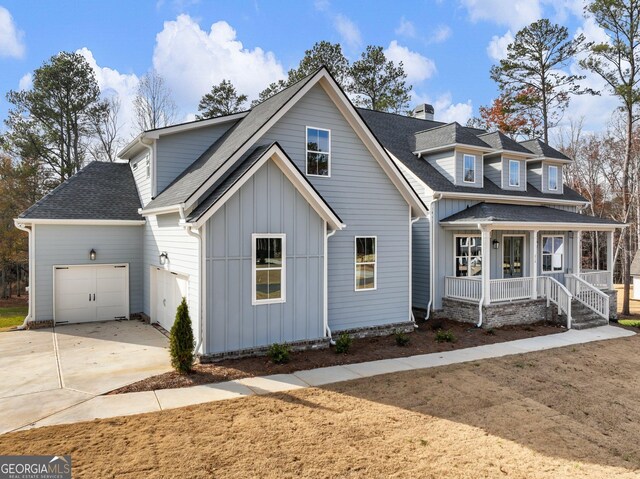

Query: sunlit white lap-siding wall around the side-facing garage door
[[143, 213, 200, 346]]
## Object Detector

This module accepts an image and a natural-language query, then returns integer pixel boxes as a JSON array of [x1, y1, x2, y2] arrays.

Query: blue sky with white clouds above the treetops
[[0, 0, 615, 142]]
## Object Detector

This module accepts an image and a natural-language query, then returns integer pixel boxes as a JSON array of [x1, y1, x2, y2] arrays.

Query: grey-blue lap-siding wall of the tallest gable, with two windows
[[261, 86, 410, 331]]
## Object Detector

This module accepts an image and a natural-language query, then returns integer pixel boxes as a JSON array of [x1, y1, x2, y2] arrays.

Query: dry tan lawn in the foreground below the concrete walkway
[[0, 337, 640, 479]]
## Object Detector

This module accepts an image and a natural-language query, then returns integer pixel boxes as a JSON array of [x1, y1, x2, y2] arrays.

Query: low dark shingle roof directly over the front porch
[[440, 203, 622, 226]]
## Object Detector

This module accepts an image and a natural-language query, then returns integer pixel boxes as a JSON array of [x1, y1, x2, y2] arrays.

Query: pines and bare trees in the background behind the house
[[0, 0, 640, 314]]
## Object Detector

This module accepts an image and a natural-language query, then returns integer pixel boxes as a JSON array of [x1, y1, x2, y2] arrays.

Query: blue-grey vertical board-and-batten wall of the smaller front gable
[[206, 161, 324, 354]]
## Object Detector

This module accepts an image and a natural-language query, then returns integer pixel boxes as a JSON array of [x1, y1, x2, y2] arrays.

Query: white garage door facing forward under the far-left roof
[[53, 264, 129, 323]]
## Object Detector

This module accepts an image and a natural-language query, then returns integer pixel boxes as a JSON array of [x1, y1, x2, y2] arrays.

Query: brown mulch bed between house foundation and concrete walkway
[[109, 320, 566, 394]]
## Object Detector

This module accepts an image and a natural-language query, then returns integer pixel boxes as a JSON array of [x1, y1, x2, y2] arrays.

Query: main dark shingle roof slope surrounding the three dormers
[[358, 108, 587, 201]]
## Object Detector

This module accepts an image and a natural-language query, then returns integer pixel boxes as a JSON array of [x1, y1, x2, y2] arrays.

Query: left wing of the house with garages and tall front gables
[[15, 69, 427, 356]]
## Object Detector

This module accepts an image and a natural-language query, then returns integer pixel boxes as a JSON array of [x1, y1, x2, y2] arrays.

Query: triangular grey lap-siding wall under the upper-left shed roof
[[156, 122, 233, 193]]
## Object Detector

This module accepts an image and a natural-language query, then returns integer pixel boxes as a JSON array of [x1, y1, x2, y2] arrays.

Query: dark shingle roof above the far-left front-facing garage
[[19, 161, 143, 220]]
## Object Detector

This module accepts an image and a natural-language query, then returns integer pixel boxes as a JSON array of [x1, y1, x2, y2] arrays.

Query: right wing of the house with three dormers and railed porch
[[360, 105, 623, 328]]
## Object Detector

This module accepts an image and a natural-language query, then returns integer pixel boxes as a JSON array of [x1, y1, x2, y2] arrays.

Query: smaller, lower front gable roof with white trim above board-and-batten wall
[[186, 142, 345, 230]]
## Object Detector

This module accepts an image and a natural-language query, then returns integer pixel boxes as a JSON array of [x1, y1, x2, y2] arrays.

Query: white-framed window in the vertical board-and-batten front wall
[[251, 234, 286, 304]]
